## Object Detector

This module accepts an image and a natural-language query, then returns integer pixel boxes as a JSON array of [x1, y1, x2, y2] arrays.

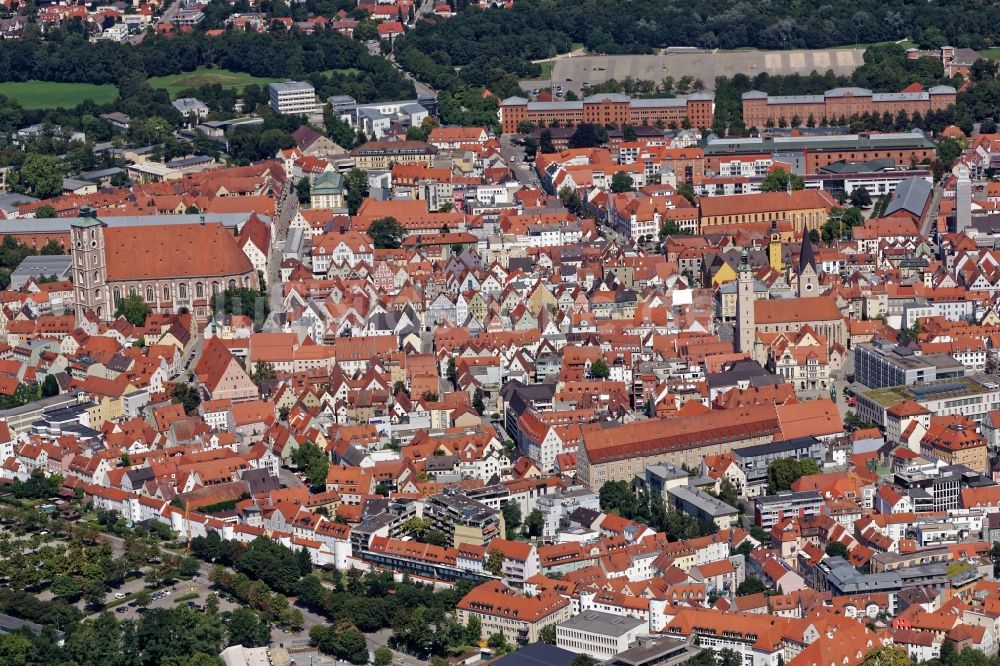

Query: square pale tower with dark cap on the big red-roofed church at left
[[70, 207, 108, 324]]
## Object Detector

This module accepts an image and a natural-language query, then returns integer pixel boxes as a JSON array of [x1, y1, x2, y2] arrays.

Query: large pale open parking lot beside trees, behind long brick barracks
[[521, 49, 864, 94]]
